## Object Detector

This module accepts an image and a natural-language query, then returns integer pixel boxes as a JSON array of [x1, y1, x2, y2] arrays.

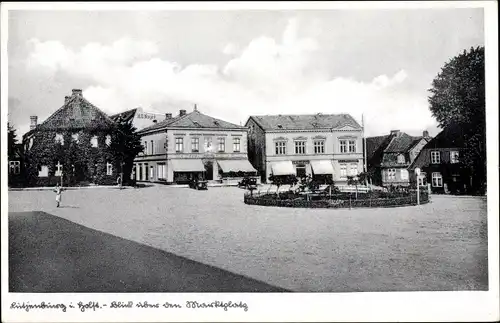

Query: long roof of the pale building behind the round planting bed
[[250, 113, 361, 130]]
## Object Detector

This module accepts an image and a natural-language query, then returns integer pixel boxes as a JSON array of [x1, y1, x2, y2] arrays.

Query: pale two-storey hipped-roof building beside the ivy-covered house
[[134, 106, 256, 184]]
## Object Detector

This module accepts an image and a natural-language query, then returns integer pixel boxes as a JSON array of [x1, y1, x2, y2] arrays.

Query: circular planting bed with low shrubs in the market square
[[244, 191, 429, 209]]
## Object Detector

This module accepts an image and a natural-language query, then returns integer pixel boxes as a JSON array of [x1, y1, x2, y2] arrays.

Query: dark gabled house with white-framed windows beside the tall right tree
[[411, 126, 473, 194]]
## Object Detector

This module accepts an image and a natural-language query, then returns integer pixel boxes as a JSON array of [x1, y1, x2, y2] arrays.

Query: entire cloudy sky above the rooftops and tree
[[7, 8, 484, 136]]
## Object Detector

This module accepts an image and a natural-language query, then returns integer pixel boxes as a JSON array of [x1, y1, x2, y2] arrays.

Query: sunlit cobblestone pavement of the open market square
[[9, 186, 488, 292]]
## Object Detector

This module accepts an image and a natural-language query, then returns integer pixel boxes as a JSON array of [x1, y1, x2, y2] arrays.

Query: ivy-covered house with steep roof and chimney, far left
[[23, 89, 118, 186]]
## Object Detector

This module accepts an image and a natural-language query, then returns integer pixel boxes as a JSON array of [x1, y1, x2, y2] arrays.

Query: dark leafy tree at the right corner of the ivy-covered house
[[110, 122, 144, 184]]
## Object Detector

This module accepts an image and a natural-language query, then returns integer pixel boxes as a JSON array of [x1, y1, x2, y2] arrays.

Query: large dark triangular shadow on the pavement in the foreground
[[9, 212, 286, 293]]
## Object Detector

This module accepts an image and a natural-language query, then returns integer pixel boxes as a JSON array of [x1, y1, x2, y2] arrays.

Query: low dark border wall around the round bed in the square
[[244, 192, 429, 209]]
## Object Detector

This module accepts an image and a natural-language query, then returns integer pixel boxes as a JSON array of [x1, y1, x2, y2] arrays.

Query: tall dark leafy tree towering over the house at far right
[[429, 47, 486, 194]]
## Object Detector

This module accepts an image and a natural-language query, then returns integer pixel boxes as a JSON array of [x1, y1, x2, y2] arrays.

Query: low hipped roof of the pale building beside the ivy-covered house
[[139, 110, 246, 133]]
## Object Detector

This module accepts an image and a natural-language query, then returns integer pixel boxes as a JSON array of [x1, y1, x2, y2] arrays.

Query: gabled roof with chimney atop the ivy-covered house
[[29, 90, 115, 133]]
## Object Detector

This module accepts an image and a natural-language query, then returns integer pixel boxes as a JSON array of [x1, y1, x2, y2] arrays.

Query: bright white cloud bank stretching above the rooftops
[[27, 19, 433, 135]]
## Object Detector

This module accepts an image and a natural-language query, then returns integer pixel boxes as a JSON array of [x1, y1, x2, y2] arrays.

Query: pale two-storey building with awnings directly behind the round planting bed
[[246, 113, 363, 184]]
